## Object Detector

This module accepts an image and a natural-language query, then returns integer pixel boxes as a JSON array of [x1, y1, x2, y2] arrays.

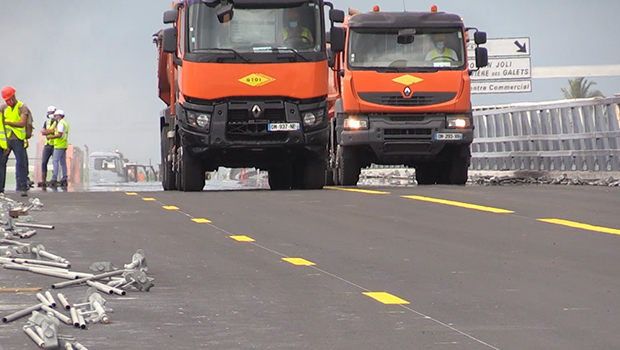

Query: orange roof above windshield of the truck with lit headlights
[[347, 12, 463, 28]]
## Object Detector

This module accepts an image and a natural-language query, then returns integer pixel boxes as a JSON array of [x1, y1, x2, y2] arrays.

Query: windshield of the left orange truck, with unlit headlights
[[187, 2, 323, 54]]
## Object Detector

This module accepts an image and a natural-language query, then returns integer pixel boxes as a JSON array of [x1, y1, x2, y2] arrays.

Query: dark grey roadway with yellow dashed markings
[[0, 186, 620, 350]]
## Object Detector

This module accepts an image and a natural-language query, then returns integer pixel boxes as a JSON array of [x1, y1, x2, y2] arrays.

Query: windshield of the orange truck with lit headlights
[[348, 28, 465, 71]]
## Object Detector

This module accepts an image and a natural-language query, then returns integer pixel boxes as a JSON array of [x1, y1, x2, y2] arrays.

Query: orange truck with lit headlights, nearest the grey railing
[[326, 7, 488, 186]]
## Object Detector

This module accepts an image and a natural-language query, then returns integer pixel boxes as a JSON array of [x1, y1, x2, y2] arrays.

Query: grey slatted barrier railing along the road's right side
[[471, 95, 620, 171]]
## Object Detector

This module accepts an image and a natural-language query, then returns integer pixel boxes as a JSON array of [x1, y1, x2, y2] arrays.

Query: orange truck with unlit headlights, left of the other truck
[[154, 0, 344, 191]]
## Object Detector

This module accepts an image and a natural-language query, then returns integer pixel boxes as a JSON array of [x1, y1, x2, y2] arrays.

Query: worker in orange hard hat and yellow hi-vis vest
[[0, 86, 32, 197]]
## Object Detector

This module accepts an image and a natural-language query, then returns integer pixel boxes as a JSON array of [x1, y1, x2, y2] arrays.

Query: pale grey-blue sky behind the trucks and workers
[[0, 0, 620, 165]]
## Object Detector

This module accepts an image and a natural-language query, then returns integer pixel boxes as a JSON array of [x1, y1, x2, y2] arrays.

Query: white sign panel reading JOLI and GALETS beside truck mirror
[[469, 57, 532, 81]]
